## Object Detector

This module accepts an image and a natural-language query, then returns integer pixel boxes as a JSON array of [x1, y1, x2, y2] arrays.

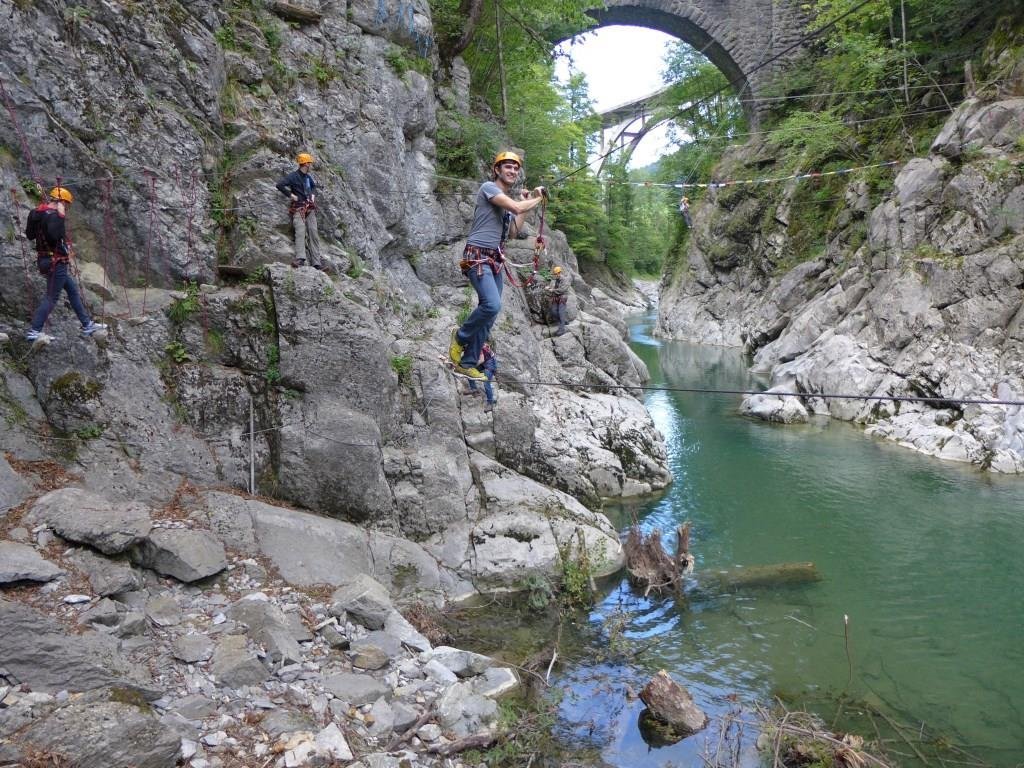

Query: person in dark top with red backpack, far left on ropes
[[25, 186, 106, 344]]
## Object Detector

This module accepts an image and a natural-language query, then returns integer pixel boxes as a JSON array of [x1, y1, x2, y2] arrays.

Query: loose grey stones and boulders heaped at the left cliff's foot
[[0, 487, 518, 768]]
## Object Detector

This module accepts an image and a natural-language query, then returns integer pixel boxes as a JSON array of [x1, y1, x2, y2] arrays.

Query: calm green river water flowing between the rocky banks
[[536, 316, 1024, 768]]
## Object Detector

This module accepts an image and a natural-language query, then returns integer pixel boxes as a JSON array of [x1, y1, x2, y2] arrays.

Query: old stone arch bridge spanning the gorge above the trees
[[588, 0, 808, 124]]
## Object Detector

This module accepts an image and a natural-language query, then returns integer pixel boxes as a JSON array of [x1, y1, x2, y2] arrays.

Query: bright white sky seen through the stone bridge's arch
[[556, 27, 673, 170]]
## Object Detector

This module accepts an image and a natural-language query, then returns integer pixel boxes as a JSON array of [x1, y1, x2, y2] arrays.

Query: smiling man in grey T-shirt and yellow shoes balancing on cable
[[449, 152, 545, 381]]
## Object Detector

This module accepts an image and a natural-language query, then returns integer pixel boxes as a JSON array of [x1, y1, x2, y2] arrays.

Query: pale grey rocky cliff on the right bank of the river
[[658, 98, 1024, 473]]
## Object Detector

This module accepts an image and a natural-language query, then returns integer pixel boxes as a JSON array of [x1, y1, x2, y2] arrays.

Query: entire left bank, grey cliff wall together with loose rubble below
[[0, 0, 671, 768]]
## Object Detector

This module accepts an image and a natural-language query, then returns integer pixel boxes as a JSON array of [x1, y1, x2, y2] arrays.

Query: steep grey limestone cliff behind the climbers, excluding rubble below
[[0, 0, 670, 588]]
